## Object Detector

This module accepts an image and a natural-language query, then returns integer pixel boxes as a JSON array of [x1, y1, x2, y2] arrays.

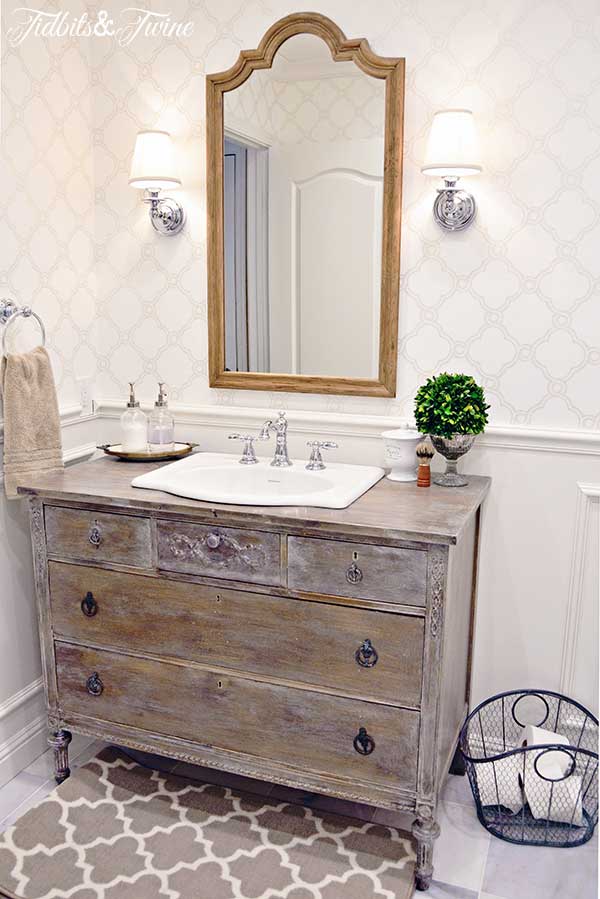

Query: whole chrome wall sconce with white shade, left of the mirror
[[129, 131, 185, 234]]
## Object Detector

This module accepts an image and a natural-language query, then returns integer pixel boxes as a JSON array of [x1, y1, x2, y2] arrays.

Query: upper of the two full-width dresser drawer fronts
[[49, 562, 423, 707]]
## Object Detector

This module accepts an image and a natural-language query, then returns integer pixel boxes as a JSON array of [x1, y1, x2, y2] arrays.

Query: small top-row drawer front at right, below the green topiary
[[288, 537, 427, 606]]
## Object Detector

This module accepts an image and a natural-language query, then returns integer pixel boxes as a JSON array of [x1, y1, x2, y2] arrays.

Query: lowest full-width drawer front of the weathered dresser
[[56, 643, 419, 789]]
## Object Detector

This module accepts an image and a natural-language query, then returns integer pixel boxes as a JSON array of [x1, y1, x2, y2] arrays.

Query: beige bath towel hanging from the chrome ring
[[0, 347, 63, 499]]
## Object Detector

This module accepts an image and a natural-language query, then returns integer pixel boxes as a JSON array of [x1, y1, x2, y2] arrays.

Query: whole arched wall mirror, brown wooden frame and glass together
[[207, 13, 404, 396]]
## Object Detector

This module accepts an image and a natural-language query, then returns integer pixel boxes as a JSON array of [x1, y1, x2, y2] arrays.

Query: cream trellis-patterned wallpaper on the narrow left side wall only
[[0, 0, 97, 405]]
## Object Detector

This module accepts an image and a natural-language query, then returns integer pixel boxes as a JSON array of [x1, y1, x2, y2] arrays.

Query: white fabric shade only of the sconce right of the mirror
[[421, 109, 481, 179]]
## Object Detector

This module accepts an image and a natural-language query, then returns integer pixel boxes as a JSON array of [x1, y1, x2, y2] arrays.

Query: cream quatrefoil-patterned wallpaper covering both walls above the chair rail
[[0, 0, 600, 430]]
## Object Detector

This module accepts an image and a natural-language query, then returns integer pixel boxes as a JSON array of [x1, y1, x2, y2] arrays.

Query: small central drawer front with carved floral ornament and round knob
[[158, 521, 281, 584]]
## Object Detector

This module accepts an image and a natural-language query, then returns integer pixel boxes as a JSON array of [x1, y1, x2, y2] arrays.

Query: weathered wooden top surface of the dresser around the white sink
[[19, 458, 490, 544]]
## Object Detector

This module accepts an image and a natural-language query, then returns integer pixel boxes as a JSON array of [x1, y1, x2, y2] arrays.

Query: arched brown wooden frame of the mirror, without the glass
[[206, 13, 404, 396]]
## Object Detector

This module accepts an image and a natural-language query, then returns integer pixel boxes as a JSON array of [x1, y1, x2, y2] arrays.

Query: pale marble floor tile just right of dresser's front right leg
[[433, 802, 490, 899]]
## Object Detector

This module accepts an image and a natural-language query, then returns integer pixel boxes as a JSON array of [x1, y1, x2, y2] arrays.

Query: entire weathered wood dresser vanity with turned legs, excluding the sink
[[22, 459, 489, 889]]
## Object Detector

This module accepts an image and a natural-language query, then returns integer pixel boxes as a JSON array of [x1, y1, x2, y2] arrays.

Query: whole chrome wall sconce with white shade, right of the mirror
[[421, 109, 481, 231]]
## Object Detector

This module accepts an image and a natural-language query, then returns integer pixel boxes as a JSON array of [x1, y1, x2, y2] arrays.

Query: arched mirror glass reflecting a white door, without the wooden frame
[[224, 34, 385, 378]]
